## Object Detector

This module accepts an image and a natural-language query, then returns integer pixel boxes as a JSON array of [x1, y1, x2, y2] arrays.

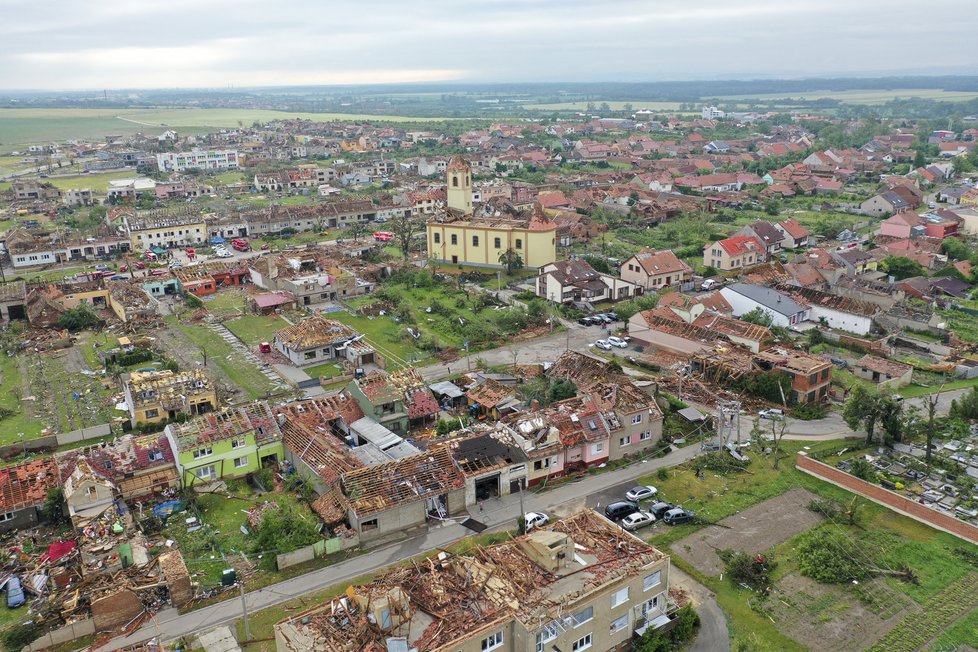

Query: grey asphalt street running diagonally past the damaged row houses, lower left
[[99, 444, 699, 652]]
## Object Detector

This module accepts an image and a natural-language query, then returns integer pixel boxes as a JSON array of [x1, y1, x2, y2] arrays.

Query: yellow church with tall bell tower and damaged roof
[[426, 156, 557, 269]]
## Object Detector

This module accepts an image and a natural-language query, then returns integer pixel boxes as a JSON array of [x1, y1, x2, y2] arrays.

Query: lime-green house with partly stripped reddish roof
[[165, 401, 284, 487]]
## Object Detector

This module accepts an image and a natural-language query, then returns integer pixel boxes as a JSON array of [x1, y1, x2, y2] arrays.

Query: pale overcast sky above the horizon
[[0, 0, 978, 90]]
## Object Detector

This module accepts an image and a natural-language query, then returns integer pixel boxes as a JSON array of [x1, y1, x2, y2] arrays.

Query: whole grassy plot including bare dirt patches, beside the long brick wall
[[639, 441, 978, 652]]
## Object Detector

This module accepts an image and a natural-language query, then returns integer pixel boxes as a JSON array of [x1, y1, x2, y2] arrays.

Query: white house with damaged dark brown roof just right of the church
[[536, 258, 642, 304]]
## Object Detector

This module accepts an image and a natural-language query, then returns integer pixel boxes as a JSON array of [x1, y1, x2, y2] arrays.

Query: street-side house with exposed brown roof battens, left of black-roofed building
[[340, 446, 465, 544]]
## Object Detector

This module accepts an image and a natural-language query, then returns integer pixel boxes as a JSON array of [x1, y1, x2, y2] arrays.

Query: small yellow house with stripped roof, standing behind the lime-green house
[[122, 369, 218, 425]]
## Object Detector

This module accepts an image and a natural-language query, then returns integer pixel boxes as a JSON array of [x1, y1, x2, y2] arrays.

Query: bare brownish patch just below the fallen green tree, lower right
[[761, 572, 920, 652]]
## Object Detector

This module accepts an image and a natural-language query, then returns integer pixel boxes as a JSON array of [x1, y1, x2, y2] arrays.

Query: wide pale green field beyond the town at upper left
[[0, 109, 448, 149]]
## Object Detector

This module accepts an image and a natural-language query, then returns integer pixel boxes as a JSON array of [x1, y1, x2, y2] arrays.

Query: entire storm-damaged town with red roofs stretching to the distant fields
[[0, 91, 978, 652]]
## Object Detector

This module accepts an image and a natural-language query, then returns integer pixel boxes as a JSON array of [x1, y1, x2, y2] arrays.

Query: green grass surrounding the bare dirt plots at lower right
[[624, 440, 978, 651]]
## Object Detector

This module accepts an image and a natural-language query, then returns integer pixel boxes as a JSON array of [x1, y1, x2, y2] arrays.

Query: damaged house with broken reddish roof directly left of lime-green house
[[55, 434, 180, 501]]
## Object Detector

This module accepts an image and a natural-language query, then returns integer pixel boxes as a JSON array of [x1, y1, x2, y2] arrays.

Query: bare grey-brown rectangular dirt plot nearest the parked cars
[[672, 489, 822, 575]]
